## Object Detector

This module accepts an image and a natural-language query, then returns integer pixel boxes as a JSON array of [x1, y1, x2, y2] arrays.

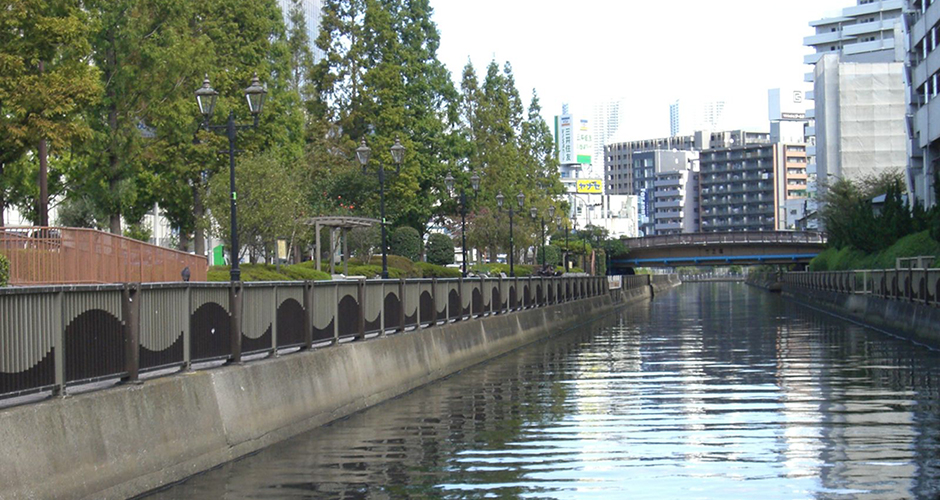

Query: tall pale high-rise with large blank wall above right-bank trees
[[803, 0, 907, 197]]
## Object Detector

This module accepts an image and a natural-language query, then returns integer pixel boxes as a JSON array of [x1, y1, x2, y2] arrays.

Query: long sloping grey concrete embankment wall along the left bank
[[0, 285, 665, 499]]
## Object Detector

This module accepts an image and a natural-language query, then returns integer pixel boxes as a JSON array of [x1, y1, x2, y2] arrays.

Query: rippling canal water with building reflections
[[150, 283, 940, 500]]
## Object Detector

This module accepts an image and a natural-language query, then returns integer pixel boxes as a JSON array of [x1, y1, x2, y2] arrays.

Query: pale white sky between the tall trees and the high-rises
[[431, 0, 856, 139]]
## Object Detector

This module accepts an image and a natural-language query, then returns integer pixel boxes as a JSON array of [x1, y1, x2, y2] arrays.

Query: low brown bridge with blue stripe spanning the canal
[[611, 231, 826, 272]]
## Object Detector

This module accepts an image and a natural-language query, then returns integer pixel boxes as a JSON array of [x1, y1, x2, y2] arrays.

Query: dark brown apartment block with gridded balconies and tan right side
[[700, 142, 807, 232]]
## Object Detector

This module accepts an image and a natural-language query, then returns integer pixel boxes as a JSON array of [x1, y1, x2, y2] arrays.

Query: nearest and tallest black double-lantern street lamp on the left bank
[[196, 73, 268, 281]]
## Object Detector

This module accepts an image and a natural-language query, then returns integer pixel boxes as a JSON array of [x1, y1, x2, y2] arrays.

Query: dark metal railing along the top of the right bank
[[782, 269, 940, 307]]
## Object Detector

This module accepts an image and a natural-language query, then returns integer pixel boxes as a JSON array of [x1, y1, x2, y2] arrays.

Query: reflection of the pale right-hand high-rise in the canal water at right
[[777, 310, 923, 500]]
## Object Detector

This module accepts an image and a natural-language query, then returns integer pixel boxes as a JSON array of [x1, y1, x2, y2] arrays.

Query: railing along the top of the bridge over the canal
[[623, 231, 826, 249]]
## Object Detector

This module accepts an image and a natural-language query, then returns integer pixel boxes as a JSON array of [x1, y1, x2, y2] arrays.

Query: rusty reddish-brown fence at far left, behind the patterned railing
[[0, 227, 209, 286]]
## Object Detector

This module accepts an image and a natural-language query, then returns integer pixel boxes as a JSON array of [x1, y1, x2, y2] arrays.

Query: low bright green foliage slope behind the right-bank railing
[[809, 231, 940, 271]]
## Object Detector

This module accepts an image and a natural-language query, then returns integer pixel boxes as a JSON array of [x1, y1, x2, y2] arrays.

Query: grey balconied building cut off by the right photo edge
[[905, 0, 940, 206]]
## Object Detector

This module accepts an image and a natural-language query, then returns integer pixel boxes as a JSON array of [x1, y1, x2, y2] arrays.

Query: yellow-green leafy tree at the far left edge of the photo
[[0, 0, 100, 226]]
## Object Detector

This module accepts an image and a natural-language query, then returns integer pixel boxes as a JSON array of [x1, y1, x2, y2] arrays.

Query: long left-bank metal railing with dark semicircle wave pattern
[[0, 276, 616, 397]]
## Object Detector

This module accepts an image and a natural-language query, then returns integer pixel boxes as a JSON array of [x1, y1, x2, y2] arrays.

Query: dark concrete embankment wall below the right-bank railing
[[781, 283, 940, 349]]
